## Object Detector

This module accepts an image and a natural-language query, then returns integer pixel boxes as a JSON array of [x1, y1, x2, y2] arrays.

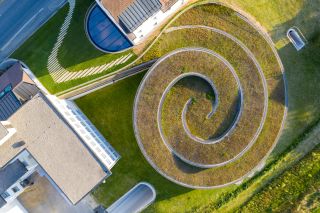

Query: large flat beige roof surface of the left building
[[0, 93, 109, 204]]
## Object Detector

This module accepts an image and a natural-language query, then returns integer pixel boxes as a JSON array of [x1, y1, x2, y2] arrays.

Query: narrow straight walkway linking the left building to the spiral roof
[[59, 59, 158, 100]]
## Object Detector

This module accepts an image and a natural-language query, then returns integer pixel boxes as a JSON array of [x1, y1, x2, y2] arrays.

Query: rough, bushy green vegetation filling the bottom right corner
[[238, 143, 320, 213]]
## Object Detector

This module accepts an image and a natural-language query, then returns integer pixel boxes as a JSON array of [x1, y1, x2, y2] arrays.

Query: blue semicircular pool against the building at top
[[86, 4, 133, 53]]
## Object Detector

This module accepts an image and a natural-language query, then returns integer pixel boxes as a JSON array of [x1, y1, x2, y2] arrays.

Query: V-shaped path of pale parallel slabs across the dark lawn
[[47, 0, 133, 83]]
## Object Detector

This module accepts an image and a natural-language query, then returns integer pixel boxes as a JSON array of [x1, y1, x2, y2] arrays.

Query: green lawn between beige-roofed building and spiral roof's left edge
[[76, 74, 235, 212]]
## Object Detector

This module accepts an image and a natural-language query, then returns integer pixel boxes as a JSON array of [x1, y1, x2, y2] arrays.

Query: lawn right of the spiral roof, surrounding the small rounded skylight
[[222, 0, 320, 159]]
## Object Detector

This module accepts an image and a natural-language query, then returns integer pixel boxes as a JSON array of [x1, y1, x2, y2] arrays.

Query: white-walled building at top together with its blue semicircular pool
[[86, 0, 187, 52]]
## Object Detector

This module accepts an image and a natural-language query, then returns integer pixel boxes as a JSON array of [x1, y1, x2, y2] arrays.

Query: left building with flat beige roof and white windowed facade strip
[[0, 63, 120, 208]]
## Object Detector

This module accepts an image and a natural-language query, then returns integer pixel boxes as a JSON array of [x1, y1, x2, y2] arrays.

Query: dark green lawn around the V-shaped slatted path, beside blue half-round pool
[[11, 0, 136, 94]]
